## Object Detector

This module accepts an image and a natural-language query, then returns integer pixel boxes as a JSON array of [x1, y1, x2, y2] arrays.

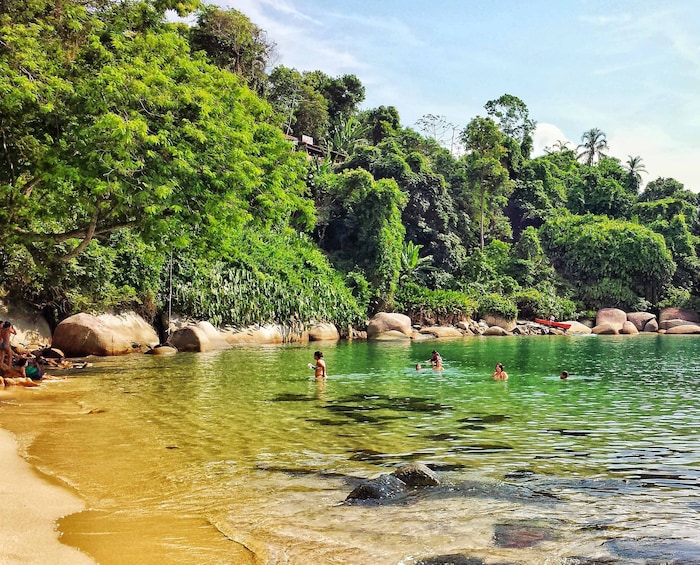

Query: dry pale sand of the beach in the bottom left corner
[[0, 428, 95, 565]]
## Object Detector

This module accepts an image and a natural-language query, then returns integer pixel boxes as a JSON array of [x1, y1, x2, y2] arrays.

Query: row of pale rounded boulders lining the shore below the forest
[[0, 304, 700, 357]]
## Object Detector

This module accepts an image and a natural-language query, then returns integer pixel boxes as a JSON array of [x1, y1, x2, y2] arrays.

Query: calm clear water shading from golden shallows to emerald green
[[0, 335, 700, 565]]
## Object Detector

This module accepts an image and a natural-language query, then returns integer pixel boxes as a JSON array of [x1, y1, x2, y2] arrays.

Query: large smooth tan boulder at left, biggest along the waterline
[[51, 312, 159, 357]]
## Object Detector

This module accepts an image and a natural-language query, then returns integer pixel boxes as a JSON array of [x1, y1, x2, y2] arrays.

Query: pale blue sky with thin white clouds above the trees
[[216, 0, 700, 192]]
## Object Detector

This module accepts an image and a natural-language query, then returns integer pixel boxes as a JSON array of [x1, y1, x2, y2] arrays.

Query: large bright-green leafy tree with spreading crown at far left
[[0, 2, 320, 320]]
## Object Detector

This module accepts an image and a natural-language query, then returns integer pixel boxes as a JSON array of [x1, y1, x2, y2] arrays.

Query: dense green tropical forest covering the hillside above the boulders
[[0, 0, 700, 333]]
